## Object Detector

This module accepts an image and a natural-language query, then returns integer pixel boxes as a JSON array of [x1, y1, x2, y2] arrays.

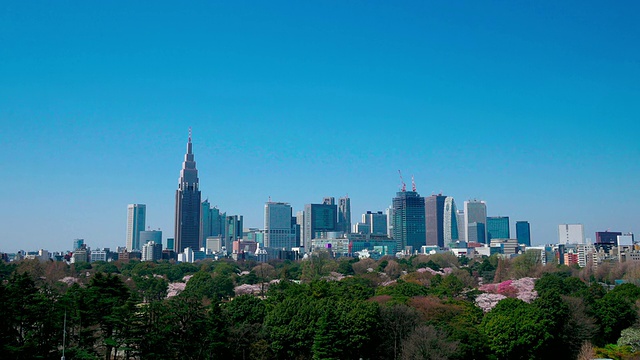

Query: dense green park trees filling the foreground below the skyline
[[0, 253, 640, 360]]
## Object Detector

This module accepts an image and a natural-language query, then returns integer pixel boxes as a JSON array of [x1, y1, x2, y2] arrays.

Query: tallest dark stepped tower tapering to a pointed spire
[[174, 128, 200, 253]]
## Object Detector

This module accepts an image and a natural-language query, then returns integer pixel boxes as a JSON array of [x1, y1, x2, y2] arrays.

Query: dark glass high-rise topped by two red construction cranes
[[391, 191, 427, 252]]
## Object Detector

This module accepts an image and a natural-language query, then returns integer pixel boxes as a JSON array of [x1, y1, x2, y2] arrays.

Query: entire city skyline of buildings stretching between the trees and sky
[[1, 128, 640, 267]]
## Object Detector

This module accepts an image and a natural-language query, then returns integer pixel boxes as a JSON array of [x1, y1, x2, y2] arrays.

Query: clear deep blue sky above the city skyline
[[0, 0, 640, 252]]
